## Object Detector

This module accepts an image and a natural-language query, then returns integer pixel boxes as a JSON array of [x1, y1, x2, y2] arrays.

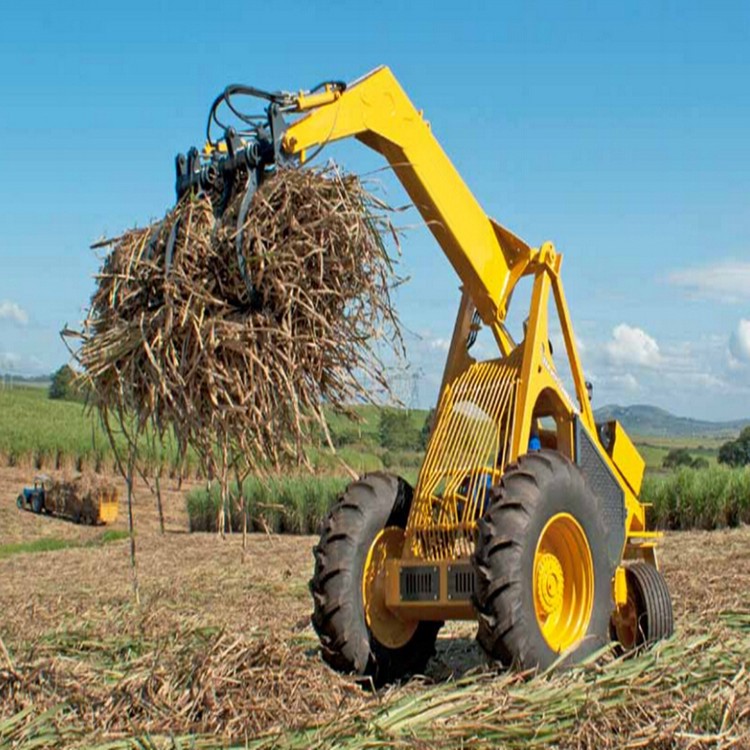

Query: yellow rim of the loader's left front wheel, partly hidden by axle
[[362, 526, 419, 648]]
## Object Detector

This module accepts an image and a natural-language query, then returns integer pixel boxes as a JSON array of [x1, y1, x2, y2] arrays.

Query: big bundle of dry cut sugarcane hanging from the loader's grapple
[[67, 167, 400, 478]]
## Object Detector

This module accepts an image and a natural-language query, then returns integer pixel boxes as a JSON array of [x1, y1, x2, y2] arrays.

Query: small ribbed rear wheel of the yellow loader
[[610, 561, 674, 653]]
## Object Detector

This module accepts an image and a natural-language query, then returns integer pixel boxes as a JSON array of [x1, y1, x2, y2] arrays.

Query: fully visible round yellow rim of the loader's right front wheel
[[533, 513, 594, 653]]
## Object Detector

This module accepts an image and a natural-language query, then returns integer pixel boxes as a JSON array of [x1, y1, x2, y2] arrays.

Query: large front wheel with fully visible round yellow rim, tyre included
[[473, 450, 614, 670]]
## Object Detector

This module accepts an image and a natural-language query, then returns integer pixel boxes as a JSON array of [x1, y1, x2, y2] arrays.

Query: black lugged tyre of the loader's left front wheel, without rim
[[310, 472, 443, 687]]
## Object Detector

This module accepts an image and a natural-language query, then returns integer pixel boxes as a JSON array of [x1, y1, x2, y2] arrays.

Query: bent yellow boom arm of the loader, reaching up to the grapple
[[282, 67, 531, 332]]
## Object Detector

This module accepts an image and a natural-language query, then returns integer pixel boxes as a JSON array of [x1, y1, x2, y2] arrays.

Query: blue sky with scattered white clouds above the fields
[[0, 1, 750, 419]]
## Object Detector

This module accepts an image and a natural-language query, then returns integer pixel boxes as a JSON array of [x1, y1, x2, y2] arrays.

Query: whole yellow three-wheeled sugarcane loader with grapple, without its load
[[177, 67, 673, 684]]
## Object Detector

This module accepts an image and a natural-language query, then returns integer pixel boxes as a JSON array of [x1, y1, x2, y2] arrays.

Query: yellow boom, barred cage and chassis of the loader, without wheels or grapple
[[282, 68, 657, 628]]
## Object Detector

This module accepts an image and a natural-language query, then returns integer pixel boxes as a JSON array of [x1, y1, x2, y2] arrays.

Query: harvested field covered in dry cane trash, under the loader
[[0, 469, 750, 748]]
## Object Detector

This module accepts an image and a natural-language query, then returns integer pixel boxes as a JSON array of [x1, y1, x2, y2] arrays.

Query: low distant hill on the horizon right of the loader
[[594, 404, 750, 437]]
